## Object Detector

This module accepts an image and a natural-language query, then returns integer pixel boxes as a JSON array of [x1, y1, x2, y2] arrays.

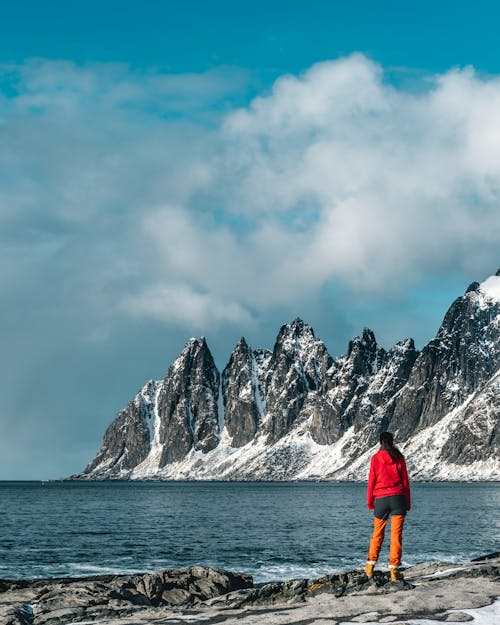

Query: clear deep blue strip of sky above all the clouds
[[0, 0, 500, 75]]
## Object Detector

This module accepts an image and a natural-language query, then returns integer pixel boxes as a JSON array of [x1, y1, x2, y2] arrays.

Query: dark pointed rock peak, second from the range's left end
[[158, 338, 220, 467]]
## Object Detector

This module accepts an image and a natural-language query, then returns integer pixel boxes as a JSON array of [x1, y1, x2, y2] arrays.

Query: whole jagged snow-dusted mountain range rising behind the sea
[[73, 270, 500, 480]]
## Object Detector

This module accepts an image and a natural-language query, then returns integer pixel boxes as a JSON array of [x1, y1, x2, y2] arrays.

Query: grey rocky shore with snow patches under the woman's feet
[[0, 552, 500, 625]]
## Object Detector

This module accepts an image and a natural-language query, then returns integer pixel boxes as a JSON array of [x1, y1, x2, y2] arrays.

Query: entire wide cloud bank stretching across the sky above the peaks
[[0, 54, 500, 330]]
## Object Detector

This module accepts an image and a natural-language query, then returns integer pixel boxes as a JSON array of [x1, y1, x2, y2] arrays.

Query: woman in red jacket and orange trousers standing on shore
[[365, 432, 411, 581]]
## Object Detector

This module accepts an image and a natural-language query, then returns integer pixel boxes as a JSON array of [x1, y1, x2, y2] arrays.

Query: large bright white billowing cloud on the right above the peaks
[[128, 55, 500, 320]]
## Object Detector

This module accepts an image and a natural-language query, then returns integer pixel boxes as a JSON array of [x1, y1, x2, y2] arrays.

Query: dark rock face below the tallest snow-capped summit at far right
[[390, 285, 500, 440]]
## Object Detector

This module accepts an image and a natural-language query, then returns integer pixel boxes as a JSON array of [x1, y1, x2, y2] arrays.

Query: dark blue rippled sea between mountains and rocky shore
[[0, 482, 500, 582]]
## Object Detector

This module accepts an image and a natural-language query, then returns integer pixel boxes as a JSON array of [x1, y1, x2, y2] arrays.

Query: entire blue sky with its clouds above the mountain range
[[0, 0, 500, 479]]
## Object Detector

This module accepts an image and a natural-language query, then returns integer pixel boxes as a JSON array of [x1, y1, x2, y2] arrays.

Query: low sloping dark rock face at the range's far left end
[[83, 380, 158, 473]]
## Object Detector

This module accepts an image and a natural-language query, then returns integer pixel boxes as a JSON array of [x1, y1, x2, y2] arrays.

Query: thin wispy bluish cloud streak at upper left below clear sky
[[0, 58, 248, 121]]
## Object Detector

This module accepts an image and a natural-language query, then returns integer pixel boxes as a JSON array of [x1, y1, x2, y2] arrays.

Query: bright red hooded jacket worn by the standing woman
[[367, 449, 411, 510]]
